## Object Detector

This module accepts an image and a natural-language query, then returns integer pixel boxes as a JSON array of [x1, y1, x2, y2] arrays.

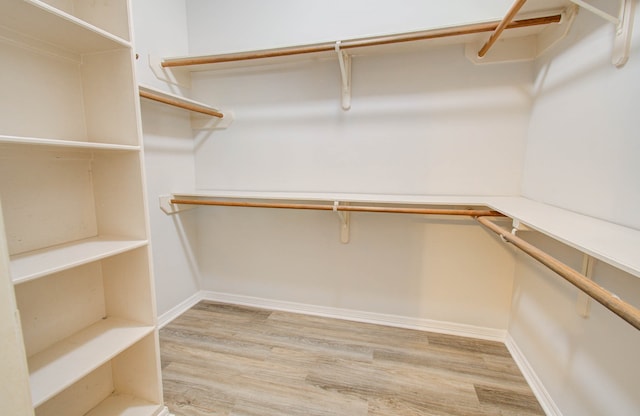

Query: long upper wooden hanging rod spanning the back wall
[[161, 14, 562, 68]]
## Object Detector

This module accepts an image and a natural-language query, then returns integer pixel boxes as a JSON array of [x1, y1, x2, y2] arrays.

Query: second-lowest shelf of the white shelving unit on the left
[[28, 317, 154, 407]]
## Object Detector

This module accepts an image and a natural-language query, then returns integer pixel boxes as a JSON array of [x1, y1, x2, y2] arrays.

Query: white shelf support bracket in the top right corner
[[571, 0, 636, 68]]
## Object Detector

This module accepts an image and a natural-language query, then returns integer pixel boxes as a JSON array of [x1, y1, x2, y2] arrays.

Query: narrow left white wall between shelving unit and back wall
[[132, 0, 199, 315]]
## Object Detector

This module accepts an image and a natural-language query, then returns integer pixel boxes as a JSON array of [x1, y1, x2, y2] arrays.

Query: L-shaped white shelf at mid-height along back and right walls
[[173, 191, 640, 277]]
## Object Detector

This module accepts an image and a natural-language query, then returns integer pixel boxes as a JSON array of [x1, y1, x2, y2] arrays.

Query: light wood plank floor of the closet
[[160, 302, 544, 416]]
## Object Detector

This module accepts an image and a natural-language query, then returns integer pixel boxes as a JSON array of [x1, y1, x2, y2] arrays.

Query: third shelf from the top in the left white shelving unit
[[10, 236, 147, 284]]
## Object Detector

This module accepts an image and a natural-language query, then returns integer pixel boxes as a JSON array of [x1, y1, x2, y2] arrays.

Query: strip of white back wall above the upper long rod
[[187, 0, 550, 55]]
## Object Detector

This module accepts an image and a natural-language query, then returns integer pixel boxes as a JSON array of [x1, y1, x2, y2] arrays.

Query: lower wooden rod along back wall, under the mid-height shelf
[[171, 199, 503, 217]]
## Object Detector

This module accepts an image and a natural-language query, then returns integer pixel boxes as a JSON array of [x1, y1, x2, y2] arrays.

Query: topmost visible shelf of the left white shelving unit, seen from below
[[0, 0, 131, 54]]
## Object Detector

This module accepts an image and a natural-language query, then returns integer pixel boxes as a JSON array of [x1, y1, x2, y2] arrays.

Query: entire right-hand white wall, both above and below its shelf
[[509, 2, 640, 415]]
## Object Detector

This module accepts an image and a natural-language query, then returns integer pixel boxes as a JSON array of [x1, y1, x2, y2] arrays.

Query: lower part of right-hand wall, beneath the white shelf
[[509, 232, 640, 416]]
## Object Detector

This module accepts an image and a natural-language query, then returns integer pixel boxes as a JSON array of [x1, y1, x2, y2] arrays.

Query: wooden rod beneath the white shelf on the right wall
[[476, 217, 640, 329]]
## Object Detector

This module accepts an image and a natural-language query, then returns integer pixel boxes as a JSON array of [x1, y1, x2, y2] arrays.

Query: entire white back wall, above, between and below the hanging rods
[[181, 1, 533, 329]]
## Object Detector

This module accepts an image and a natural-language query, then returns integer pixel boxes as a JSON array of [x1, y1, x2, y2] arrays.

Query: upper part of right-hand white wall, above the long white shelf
[[523, 1, 640, 229]]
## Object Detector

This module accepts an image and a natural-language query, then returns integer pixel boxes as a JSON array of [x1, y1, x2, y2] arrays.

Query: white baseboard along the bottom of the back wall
[[200, 291, 507, 342]]
